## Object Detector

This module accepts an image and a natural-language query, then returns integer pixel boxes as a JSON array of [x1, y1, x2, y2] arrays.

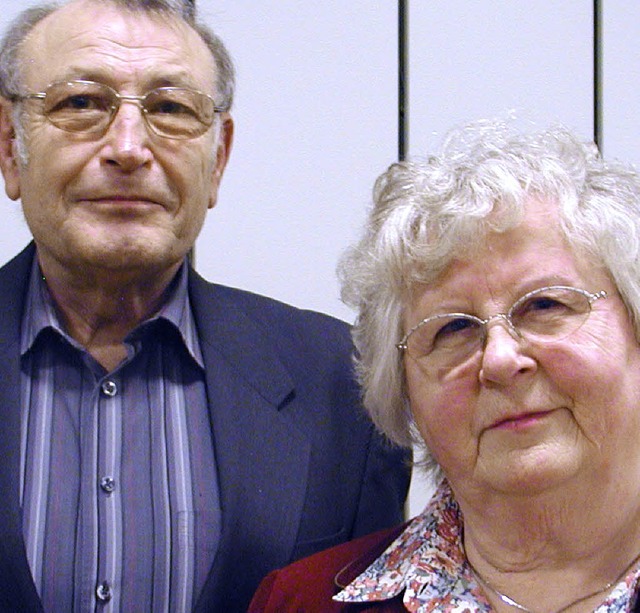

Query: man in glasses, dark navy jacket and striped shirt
[[0, 0, 407, 612]]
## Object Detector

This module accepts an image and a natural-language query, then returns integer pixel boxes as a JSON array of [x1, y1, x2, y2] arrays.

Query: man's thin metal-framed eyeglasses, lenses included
[[15, 81, 227, 139]]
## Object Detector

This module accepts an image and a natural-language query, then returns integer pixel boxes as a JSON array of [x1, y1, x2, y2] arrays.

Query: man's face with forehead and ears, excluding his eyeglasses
[[2, 0, 232, 275]]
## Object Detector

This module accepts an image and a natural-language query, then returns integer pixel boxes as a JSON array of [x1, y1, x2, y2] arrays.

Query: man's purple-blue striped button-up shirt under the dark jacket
[[20, 261, 220, 613]]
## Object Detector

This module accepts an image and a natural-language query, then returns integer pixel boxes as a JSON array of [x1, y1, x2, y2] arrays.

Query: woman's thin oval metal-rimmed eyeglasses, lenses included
[[396, 285, 607, 372]]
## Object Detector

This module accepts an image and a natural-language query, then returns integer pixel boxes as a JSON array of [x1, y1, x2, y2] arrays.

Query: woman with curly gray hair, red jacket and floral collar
[[251, 124, 640, 613]]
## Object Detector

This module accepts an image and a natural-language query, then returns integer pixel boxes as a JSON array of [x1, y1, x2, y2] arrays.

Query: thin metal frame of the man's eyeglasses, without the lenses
[[10, 79, 229, 140]]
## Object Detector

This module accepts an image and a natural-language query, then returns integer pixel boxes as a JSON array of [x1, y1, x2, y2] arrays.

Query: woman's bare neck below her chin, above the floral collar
[[459, 482, 640, 613]]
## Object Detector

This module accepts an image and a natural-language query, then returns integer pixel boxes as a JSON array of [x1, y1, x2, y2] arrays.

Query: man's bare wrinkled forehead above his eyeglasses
[[21, 0, 215, 89]]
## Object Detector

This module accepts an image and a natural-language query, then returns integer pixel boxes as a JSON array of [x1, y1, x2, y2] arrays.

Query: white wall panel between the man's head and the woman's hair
[[196, 0, 397, 319]]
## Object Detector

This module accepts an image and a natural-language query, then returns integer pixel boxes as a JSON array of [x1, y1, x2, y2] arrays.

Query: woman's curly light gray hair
[[339, 122, 640, 470]]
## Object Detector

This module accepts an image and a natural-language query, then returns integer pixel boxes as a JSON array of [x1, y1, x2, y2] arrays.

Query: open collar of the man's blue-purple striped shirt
[[20, 257, 204, 368]]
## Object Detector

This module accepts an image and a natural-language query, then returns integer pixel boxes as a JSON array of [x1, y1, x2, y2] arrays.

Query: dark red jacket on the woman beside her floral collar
[[249, 524, 406, 613]]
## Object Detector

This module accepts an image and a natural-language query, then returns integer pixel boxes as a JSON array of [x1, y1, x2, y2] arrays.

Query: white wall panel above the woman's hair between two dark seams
[[409, 0, 593, 155]]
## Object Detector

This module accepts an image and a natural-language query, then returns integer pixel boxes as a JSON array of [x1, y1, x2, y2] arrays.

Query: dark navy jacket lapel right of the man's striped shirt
[[190, 273, 311, 610]]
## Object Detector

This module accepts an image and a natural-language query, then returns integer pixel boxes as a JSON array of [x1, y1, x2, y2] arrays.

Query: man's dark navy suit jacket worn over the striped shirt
[[0, 245, 408, 612]]
